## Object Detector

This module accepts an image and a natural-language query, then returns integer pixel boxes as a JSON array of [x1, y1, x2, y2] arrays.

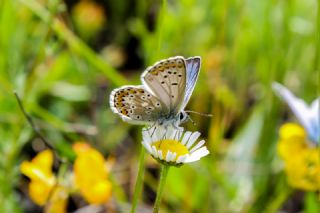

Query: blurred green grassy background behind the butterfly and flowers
[[0, 0, 320, 213]]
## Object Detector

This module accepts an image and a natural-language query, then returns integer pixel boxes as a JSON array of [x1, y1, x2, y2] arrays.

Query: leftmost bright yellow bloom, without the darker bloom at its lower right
[[20, 150, 56, 206]]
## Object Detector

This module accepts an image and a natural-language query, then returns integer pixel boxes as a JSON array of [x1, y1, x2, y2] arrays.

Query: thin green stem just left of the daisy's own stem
[[131, 146, 146, 213]]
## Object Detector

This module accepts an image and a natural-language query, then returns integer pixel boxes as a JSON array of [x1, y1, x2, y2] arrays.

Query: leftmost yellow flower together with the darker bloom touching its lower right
[[20, 150, 68, 213]]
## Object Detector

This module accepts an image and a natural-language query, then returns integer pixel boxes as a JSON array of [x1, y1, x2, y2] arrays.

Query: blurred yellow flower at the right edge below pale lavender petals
[[278, 123, 320, 191]]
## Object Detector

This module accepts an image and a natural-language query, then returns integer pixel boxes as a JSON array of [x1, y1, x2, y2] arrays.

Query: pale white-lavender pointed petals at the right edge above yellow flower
[[272, 83, 320, 144]]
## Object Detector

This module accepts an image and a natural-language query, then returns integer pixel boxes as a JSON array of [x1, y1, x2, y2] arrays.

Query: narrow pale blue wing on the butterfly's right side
[[182, 56, 201, 109]]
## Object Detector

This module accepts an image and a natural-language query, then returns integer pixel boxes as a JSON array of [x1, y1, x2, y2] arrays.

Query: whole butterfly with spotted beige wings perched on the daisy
[[110, 56, 201, 128]]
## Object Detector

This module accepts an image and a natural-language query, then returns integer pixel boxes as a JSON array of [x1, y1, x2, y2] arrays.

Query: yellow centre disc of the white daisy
[[152, 139, 189, 160]]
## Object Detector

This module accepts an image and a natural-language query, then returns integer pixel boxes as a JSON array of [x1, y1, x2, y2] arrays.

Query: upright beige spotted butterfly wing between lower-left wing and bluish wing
[[141, 56, 186, 115]]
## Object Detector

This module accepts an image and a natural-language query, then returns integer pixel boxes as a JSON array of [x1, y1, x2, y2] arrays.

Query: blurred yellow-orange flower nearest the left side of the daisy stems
[[73, 142, 112, 204]]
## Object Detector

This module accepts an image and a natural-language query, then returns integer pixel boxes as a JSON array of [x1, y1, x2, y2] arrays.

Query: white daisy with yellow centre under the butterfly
[[142, 126, 209, 166]]
